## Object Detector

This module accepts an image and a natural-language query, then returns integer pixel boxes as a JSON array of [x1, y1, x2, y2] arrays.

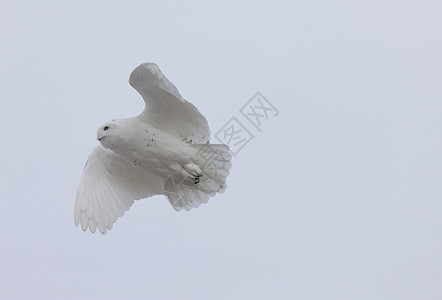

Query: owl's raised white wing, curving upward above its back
[[129, 63, 210, 143]]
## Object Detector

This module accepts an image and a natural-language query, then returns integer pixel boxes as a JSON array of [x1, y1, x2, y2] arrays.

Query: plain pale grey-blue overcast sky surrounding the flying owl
[[0, 0, 442, 299]]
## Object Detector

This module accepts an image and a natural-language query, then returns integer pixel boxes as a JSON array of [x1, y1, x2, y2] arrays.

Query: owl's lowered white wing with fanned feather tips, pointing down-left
[[74, 146, 164, 234]]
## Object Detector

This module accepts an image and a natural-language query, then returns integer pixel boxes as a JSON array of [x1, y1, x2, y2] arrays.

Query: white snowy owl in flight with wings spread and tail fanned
[[74, 63, 232, 234]]
